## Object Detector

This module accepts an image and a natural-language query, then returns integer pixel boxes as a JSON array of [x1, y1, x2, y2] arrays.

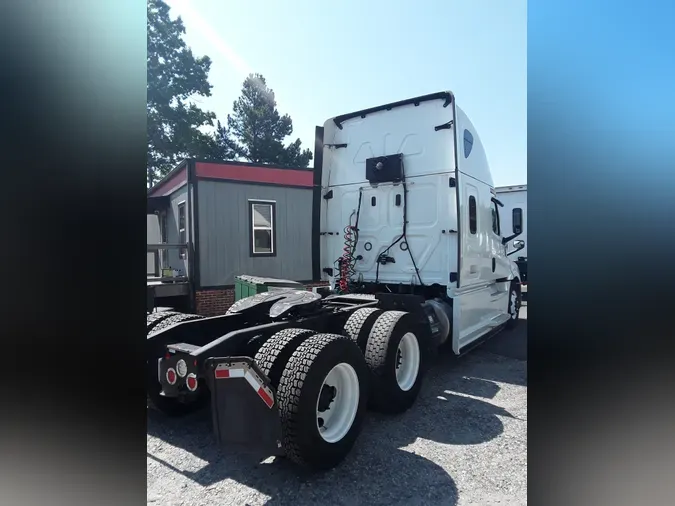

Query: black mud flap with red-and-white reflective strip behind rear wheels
[[205, 357, 282, 456]]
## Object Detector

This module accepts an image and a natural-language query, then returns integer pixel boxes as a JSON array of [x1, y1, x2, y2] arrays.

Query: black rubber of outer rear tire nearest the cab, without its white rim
[[365, 311, 428, 413]]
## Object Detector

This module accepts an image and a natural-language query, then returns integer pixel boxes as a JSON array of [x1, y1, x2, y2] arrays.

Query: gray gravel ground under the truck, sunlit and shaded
[[147, 303, 527, 506]]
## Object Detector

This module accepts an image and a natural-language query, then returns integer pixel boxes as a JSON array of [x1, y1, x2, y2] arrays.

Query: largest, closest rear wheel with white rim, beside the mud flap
[[277, 334, 368, 470]]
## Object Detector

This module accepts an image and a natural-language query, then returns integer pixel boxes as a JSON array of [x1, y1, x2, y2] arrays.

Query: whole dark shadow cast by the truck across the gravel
[[148, 310, 527, 505]]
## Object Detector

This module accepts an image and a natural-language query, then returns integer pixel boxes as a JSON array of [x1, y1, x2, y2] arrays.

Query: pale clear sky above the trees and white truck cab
[[167, 0, 527, 186]]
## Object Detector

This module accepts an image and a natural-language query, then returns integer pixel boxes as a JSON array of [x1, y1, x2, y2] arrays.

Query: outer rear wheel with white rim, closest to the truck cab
[[365, 311, 427, 413]]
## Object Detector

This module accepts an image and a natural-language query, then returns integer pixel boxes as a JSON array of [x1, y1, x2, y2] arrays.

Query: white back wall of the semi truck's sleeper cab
[[320, 96, 457, 285]]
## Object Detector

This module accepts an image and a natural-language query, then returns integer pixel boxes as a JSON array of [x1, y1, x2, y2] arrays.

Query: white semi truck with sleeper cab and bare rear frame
[[146, 91, 522, 469]]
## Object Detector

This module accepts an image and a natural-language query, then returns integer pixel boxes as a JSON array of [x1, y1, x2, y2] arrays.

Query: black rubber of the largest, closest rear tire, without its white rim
[[277, 334, 369, 470]]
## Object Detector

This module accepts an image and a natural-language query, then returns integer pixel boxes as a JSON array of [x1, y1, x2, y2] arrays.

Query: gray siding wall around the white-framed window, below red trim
[[198, 180, 312, 286]]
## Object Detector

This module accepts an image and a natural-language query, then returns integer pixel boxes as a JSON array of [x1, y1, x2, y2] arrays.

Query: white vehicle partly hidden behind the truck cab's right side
[[495, 184, 527, 285]]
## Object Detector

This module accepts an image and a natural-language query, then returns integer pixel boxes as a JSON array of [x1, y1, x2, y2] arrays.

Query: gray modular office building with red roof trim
[[148, 160, 314, 316]]
